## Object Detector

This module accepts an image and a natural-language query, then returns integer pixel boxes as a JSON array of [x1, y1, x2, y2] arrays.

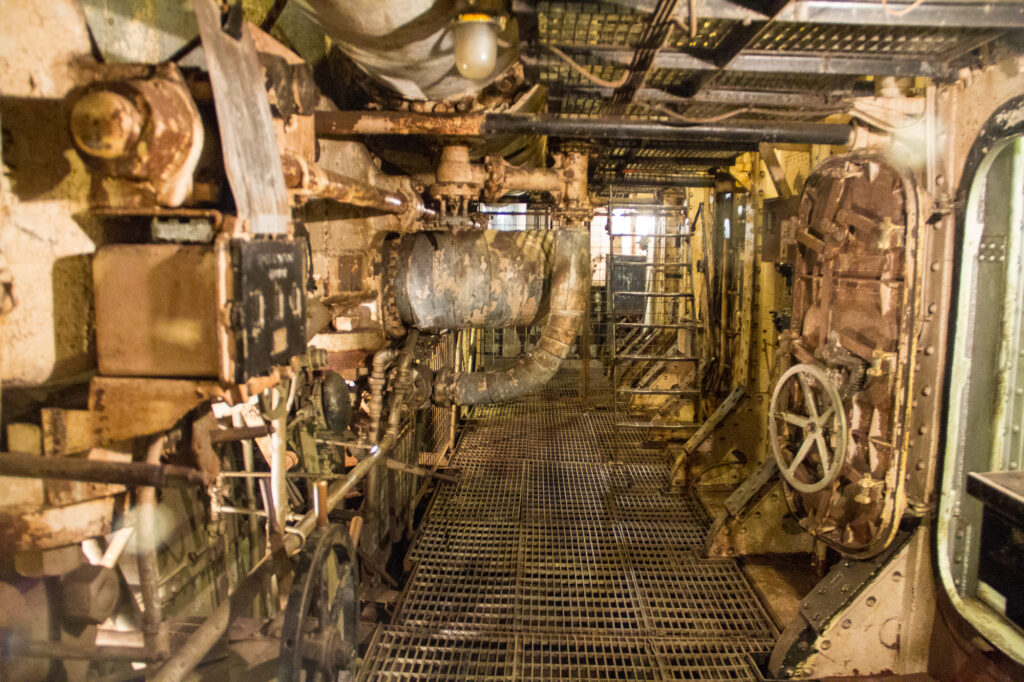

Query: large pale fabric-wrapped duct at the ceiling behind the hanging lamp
[[299, 0, 518, 100]]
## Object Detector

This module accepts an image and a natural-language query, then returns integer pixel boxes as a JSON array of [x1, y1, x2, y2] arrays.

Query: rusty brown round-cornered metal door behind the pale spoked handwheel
[[770, 155, 919, 557]]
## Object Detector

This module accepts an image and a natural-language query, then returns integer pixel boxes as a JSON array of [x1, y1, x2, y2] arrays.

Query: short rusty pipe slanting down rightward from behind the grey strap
[[281, 154, 433, 217]]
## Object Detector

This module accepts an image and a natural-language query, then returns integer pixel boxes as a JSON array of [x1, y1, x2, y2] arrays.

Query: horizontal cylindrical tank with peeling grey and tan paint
[[394, 229, 555, 332]]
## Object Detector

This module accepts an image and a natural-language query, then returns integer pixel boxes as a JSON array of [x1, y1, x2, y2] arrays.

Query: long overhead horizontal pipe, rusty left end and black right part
[[316, 112, 853, 144]]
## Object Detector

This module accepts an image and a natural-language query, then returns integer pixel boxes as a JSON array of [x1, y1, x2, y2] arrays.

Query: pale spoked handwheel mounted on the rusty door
[[768, 365, 848, 493]]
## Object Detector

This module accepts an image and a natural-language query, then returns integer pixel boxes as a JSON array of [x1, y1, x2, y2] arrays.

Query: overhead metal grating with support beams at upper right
[[511, 0, 1024, 191]]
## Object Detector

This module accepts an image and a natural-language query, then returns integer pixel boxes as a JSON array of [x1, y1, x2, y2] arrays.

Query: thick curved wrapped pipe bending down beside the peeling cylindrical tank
[[434, 230, 590, 404]]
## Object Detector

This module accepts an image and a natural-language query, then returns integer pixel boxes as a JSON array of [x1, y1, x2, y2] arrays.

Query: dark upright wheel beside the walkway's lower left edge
[[278, 524, 359, 682]]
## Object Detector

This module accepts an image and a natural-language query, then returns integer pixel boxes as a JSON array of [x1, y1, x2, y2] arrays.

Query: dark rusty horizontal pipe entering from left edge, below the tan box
[[0, 453, 207, 487]]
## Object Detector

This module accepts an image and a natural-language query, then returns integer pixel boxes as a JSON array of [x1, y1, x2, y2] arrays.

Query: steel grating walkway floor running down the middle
[[360, 368, 776, 680]]
